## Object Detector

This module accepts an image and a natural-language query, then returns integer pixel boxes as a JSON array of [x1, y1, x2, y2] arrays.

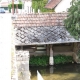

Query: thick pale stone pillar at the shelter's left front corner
[[16, 51, 31, 80]]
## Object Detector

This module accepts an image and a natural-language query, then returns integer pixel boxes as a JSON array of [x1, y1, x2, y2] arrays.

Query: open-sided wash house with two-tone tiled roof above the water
[[13, 13, 80, 64]]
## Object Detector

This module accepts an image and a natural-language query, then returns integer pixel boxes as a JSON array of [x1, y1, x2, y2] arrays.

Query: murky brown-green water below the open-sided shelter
[[30, 64, 80, 80]]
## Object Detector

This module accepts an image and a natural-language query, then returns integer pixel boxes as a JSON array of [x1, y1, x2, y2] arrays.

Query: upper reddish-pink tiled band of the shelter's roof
[[13, 13, 67, 27]]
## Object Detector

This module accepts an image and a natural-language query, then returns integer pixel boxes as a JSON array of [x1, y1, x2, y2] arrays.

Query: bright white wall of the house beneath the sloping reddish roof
[[55, 0, 72, 12]]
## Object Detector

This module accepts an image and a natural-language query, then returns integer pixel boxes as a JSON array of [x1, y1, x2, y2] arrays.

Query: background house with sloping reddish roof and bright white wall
[[45, 0, 72, 12]]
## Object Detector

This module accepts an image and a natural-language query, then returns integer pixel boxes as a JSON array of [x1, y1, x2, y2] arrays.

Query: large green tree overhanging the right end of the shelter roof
[[64, 0, 80, 39]]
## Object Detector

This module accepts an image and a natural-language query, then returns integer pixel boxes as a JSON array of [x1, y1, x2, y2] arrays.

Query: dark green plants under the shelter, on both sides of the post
[[29, 55, 73, 66]]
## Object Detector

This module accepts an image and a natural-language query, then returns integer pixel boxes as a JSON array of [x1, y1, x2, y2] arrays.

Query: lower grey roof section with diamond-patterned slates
[[14, 26, 79, 45]]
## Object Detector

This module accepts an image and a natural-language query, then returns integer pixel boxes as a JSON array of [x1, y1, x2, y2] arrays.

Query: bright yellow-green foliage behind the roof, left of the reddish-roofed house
[[32, 0, 54, 12]]
